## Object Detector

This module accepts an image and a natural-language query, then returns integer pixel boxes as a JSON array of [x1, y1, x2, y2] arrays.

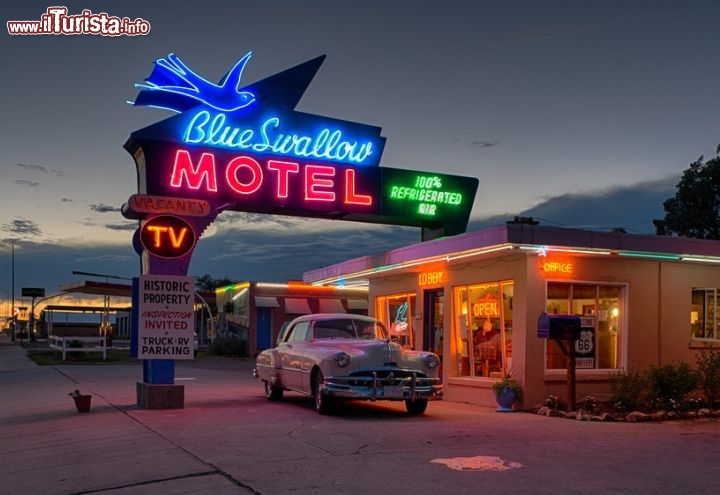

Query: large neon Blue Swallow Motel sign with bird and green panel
[[123, 53, 478, 270]]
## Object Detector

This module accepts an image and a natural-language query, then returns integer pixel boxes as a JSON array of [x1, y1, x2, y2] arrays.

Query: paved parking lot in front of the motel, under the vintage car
[[0, 344, 720, 495]]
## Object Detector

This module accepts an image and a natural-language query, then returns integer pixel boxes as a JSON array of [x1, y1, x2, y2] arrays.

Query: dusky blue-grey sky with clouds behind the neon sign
[[0, 0, 720, 316]]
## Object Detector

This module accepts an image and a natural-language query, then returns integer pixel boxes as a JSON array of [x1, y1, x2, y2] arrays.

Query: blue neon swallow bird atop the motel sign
[[134, 52, 255, 112]]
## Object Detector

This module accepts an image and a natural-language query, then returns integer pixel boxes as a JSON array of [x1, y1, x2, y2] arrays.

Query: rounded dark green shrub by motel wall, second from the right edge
[[648, 363, 700, 410]]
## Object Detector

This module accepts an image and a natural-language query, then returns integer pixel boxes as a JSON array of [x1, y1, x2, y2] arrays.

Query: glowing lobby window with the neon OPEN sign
[[453, 281, 513, 377]]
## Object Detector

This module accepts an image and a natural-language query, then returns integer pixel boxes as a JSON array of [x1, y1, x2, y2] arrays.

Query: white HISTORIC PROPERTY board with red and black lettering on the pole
[[138, 275, 195, 359]]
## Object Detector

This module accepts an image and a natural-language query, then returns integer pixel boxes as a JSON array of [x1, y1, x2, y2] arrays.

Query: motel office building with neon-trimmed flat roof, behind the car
[[304, 222, 720, 407]]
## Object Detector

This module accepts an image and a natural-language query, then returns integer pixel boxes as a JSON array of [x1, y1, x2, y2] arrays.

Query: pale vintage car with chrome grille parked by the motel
[[253, 313, 442, 414]]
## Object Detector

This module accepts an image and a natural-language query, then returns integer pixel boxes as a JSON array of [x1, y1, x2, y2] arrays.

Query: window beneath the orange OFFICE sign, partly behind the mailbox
[[545, 282, 625, 369]]
